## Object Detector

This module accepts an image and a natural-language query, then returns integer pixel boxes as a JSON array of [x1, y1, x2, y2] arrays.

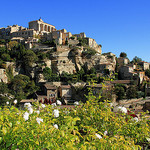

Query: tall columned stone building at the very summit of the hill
[[29, 19, 56, 33]]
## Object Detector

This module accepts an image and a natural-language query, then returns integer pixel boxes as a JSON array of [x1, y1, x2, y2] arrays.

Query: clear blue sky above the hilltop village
[[0, 0, 150, 62]]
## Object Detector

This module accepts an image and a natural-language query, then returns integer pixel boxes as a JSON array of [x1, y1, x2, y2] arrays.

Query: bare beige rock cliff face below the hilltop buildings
[[51, 47, 116, 74]]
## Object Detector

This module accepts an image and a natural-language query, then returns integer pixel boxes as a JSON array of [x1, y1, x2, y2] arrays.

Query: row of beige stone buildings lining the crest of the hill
[[0, 18, 101, 54]]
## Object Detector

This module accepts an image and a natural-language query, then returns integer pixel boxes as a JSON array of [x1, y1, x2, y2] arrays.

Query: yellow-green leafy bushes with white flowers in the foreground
[[0, 88, 150, 150]]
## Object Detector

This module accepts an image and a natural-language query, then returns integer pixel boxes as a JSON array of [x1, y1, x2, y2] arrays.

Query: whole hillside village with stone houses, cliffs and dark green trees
[[0, 18, 150, 110]]
